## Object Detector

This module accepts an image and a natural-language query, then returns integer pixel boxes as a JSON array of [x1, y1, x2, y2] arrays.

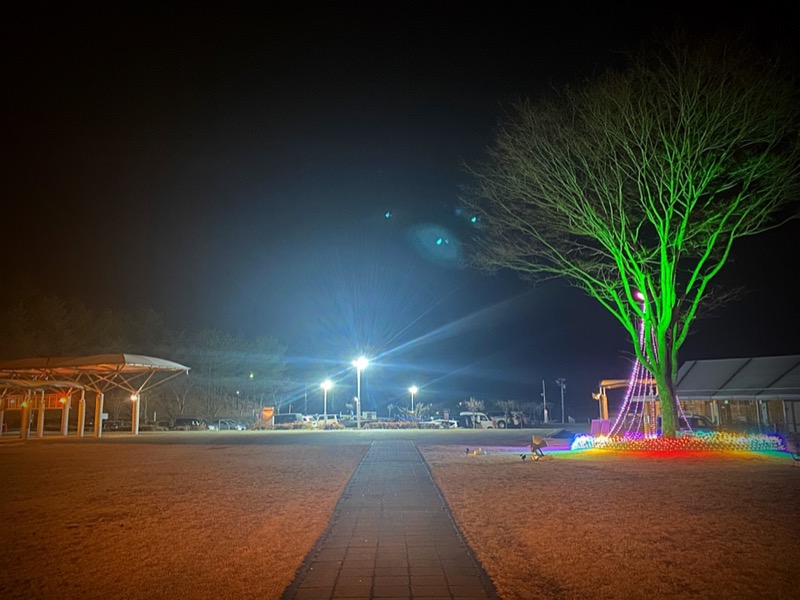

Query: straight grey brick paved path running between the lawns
[[283, 440, 497, 600]]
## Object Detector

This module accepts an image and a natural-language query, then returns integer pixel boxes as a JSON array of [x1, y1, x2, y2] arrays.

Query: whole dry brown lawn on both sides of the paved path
[[0, 432, 800, 600]]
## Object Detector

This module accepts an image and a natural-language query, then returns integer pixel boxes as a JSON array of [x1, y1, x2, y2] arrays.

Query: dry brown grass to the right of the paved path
[[423, 446, 800, 600]]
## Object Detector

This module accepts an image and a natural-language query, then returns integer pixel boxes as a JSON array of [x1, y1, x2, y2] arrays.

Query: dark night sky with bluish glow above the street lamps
[[2, 2, 800, 418]]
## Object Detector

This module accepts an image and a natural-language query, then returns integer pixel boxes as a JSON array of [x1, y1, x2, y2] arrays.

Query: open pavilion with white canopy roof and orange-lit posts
[[0, 354, 189, 439]]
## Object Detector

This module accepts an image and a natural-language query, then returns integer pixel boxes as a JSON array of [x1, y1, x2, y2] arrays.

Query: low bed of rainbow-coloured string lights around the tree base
[[571, 431, 787, 452]]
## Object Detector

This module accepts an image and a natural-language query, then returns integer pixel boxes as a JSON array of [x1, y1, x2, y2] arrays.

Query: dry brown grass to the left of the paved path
[[0, 441, 367, 600]]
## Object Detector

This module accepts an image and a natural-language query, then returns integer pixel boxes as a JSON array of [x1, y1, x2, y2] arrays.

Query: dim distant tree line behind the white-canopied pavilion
[[0, 294, 291, 418]]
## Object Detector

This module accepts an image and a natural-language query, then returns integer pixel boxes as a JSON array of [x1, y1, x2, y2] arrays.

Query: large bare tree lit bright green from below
[[465, 35, 800, 436]]
